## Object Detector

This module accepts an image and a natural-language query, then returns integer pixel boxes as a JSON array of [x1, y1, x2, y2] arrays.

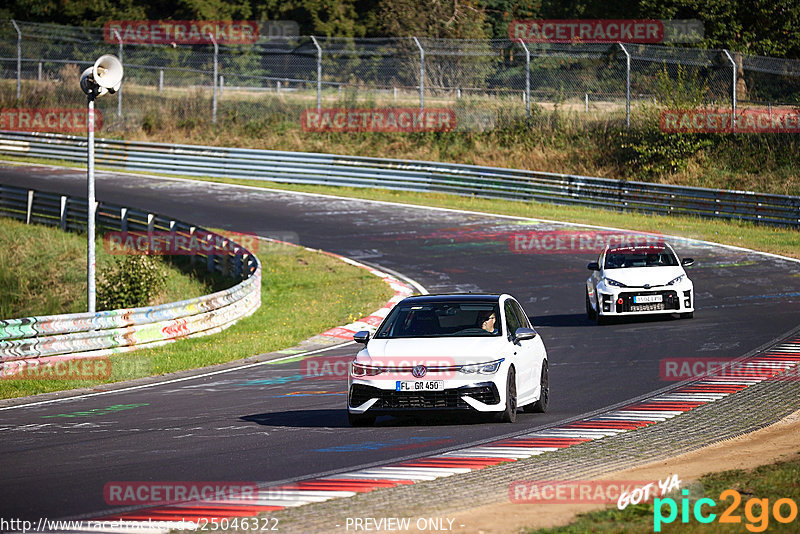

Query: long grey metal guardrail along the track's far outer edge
[[0, 132, 800, 226]]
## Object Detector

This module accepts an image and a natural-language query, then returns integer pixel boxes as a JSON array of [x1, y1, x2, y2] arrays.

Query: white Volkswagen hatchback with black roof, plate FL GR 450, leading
[[347, 294, 549, 426]]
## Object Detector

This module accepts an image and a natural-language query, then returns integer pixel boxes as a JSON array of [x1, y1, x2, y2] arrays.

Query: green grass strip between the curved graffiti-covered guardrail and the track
[[0, 224, 393, 398]]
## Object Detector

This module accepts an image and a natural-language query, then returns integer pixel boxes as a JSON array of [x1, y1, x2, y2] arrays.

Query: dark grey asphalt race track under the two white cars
[[0, 166, 800, 520]]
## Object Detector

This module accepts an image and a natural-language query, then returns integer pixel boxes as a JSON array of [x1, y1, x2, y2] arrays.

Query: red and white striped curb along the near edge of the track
[[70, 342, 800, 533]]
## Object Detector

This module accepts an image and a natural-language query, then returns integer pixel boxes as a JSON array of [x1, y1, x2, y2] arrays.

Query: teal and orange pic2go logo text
[[653, 489, 797, 532]]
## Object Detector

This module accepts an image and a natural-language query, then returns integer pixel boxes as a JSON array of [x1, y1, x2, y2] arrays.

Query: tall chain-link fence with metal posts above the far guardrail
[[0, 21, 800, 131]]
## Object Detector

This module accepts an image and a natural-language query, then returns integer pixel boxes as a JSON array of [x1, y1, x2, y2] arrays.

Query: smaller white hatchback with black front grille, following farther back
[[586, 242, 694, 323]]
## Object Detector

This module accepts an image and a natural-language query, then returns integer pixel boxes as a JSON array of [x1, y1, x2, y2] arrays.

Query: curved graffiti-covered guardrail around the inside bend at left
[[0, 185, 261, 369]]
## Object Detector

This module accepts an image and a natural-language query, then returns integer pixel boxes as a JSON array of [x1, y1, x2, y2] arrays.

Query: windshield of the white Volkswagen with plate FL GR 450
[[375, 302, 502, 338]]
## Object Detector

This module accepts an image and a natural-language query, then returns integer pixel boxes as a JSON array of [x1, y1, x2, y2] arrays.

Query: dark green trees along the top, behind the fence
[[0, 0, 800, 58]]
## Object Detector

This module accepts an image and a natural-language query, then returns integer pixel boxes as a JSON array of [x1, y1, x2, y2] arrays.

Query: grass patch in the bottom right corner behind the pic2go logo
[[526, 458, 800, 534]]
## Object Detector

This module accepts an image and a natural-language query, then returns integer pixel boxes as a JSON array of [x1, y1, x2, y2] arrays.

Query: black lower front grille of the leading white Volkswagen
[[350, 384, 500, 410]]
